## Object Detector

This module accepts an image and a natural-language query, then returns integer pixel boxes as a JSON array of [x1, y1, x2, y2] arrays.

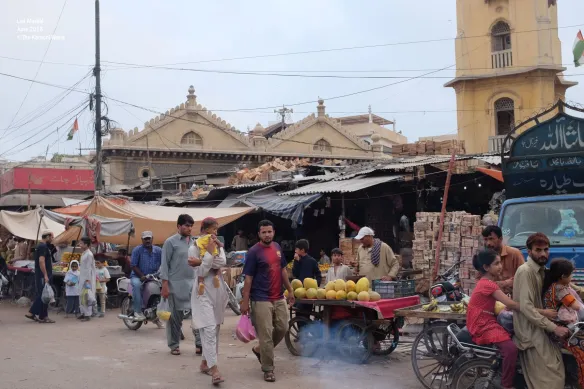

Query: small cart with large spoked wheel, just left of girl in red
[[395, 303, 466, 389]]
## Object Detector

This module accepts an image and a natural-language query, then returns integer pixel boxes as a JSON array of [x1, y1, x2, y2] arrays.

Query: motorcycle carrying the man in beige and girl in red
[[447, 322, 584, 389]]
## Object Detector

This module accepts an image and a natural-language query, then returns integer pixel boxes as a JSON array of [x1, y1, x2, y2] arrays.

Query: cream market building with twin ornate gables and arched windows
[[103, 86, 406, 186]]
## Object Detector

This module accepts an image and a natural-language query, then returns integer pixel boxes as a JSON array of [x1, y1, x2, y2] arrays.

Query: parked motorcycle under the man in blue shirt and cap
[[117, 274, 162, 331]]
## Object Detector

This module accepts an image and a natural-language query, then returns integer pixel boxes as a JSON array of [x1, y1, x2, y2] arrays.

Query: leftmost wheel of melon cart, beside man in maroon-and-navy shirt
[[284, 316, 323, 357]]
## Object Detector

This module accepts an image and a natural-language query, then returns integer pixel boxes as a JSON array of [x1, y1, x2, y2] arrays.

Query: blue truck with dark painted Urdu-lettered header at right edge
[[499, 100, 584, 285]]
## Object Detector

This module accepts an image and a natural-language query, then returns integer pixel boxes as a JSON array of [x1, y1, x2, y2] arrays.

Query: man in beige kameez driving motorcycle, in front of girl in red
[[513, 233, 569, 389]]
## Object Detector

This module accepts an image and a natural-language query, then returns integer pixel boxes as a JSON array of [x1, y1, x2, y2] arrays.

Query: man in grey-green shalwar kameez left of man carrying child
[[160, 214, 201, 355]]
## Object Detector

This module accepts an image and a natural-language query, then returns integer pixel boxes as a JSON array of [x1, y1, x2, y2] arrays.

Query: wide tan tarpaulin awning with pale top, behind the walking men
[[54, 197, 253, 246]]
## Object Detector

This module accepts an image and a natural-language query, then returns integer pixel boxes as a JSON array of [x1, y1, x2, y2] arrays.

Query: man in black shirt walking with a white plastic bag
[[25, 230, 54, 323]]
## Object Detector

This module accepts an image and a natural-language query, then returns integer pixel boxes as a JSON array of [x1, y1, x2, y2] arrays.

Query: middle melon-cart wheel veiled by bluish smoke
[[337, 321, 374, 363]]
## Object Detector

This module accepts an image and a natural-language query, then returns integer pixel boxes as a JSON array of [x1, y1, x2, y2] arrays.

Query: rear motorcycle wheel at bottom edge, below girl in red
[[450, 359, 501, 389]]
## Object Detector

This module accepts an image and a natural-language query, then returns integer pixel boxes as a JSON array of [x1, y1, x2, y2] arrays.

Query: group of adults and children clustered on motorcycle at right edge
[[467, 226, 584, 389]]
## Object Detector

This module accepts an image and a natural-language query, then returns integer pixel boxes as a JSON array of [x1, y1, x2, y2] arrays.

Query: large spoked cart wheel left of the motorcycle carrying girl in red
[[412, 325, 456, 389]]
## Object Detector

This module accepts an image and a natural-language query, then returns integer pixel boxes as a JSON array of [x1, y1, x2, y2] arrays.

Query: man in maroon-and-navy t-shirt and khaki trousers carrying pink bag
[[241, 220, 294, 382]]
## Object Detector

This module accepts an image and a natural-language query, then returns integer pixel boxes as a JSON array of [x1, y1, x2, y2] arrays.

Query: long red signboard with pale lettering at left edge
[[0, 167, 95, 194]]
